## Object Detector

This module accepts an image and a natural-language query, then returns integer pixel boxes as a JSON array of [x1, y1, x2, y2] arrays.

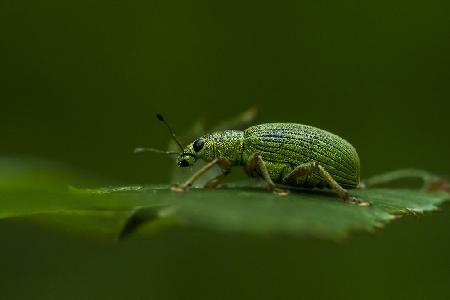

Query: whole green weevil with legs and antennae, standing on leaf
[[135, 114, 369, 206]]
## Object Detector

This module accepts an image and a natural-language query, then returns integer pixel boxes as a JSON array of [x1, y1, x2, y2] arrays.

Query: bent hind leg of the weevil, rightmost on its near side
[[283, 161, 369, 206]]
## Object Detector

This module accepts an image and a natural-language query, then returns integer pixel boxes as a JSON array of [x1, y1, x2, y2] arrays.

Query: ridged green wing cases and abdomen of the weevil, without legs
[[243, 123, 360, 188]]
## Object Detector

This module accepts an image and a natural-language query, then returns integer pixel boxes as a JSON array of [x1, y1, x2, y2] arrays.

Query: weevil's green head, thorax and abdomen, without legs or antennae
[[178, 123, 360, 188]]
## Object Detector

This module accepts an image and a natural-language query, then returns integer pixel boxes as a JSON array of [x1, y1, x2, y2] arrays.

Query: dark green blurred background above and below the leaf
[[0, 0, 450, 299]]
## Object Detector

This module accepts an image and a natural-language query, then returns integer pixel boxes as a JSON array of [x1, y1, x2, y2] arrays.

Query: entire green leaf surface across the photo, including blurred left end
[[0, 159, 450, 241]]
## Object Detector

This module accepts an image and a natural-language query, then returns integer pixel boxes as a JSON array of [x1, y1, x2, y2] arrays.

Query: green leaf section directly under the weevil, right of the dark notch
[[110, 186, 449, 240]]
